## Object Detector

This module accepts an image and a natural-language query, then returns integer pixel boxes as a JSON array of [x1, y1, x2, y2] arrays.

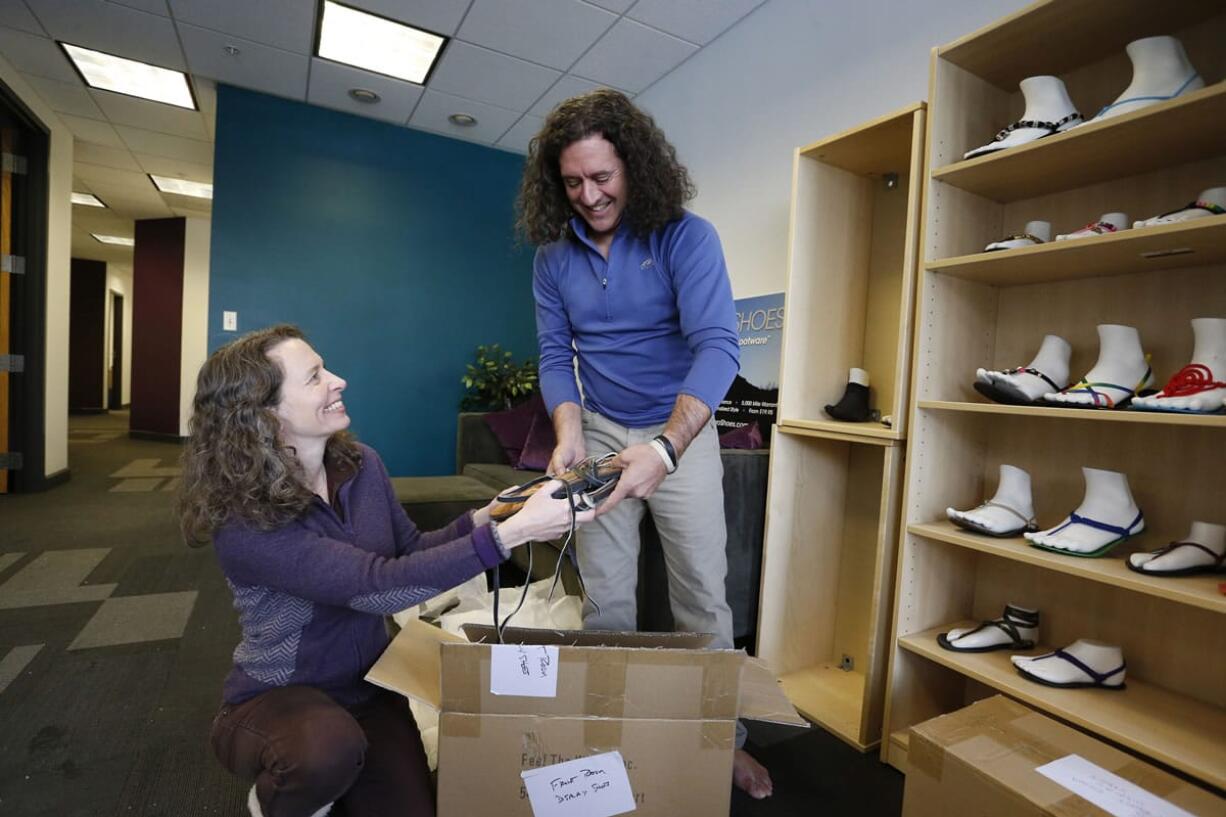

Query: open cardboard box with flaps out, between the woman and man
[[367, 621, 808, 817]]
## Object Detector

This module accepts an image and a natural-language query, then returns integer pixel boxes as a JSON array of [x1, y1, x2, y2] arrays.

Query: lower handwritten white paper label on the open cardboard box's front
[[520, 752, 634, 817]]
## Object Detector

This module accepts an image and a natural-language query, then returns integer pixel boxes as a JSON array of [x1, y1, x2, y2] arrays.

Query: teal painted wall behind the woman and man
[[208, 86, 536, 476]]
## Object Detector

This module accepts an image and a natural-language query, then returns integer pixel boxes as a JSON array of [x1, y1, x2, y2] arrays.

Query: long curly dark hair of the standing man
[[516, 88, 695, 244]]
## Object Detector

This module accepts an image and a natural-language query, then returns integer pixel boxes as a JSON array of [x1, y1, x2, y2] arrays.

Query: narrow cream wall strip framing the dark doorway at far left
[[0, 50, 72, 476]]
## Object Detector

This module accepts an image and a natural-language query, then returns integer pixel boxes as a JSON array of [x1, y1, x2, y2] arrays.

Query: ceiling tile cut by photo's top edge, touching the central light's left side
[[170, 0, 316, 54]]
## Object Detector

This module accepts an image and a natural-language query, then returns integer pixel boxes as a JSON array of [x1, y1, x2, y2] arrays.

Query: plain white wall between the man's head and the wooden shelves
[[635, 0, 1027, 298]]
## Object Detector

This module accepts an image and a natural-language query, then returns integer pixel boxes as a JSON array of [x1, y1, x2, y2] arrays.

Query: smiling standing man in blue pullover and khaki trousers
[[519, 90, 771, 799]]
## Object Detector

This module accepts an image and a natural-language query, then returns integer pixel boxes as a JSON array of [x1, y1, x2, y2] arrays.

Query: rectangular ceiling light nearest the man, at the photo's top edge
[[315, 0, 447, 85]]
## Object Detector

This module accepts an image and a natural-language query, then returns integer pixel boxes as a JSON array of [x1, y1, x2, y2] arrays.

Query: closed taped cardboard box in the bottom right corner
[[902, 692, 1226, 817]]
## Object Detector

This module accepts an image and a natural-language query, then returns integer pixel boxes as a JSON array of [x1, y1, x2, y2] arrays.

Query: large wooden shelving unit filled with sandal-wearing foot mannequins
[[881, 0, 1226, 788]]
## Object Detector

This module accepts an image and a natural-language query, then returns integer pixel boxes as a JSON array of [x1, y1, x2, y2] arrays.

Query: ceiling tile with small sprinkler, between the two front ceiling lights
[[179, 23, 310, 99]]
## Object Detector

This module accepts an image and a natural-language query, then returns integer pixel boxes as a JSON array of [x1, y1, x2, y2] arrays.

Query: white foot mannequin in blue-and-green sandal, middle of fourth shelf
[[1022, 467, 1145, 556]]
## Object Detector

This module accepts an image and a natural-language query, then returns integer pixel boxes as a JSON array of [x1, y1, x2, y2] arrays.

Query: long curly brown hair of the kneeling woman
[[178, 324, 362, 546]]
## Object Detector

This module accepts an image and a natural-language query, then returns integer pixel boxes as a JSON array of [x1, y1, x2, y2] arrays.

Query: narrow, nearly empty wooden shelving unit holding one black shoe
[[758, 103, 924, 751]]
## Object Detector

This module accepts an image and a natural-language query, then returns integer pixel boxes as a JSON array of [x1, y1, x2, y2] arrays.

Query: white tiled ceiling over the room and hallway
[[0, 0, 764, 267]]
